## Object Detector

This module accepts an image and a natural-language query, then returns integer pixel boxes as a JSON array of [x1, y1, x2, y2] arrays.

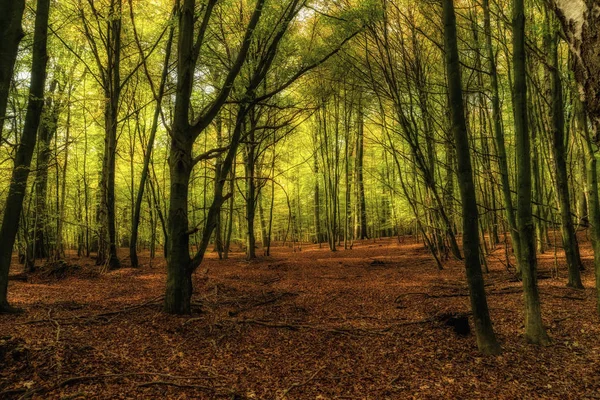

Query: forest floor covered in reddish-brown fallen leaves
[[0, 239, 600, 399]]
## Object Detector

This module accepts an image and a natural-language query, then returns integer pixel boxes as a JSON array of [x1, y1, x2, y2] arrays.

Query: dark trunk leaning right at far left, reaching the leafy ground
[[0, 0, 50, 313]]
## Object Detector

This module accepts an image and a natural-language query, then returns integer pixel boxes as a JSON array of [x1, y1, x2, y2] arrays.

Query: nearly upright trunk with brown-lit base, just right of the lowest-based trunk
[[513, 0, 549, 344]]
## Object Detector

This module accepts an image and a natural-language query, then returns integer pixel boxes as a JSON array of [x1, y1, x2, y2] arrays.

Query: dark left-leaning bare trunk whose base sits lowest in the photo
[[443, 0, 500, 354]]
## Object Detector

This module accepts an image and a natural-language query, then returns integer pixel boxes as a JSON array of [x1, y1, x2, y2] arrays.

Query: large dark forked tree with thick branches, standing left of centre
[[165, 0, 265, 314]]
